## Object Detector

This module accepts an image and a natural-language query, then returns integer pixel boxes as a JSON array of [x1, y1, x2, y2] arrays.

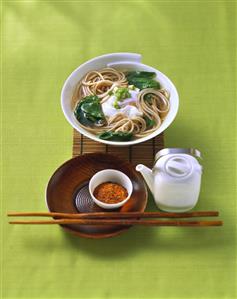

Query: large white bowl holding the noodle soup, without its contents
[[61, 53, 179, 146]]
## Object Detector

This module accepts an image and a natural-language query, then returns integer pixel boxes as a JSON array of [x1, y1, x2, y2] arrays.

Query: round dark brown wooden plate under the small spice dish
[[46, 153, 147, 238]]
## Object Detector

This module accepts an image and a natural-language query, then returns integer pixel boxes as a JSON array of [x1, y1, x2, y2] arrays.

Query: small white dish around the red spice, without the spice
[[89, 169, 133, 209]]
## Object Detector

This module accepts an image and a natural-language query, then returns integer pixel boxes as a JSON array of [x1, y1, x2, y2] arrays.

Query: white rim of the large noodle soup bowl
[[61, 53, 179, 146]]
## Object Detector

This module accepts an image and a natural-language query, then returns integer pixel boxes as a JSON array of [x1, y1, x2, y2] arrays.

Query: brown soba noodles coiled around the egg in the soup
[[72, 68, 170, 138]]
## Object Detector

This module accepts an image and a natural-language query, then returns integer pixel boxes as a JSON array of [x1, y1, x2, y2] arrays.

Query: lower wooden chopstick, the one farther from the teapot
[[9, 219, 223, 227]]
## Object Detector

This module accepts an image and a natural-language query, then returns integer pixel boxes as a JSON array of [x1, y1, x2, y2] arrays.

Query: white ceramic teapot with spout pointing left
[[136, 148, 202, 213]]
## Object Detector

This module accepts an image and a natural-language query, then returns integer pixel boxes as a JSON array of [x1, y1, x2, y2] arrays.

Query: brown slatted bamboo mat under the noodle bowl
[[72, 129, 164, 167]]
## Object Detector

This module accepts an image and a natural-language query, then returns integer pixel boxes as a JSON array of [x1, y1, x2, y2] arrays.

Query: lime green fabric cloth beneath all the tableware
[[1, 0, 236, 299]]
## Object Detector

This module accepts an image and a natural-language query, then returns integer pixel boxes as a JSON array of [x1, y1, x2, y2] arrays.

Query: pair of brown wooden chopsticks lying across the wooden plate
[[7, 211, 223, 227]]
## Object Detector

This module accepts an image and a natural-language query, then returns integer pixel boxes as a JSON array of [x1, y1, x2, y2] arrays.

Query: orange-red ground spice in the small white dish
[[93, 182, 128, 204]]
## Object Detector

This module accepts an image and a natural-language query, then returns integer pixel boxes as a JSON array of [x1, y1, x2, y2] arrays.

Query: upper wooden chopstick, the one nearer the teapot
[[7, 211, 219, 219]]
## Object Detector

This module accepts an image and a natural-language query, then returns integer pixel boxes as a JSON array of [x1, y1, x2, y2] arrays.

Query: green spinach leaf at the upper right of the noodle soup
[[126, 72, 160, 89]]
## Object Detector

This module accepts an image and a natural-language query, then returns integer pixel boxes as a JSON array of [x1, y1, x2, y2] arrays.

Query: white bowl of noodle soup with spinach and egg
[[61, 53, 179, 146]]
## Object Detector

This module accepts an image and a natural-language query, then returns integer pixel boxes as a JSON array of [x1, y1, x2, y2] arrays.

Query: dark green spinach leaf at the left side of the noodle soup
[[74, 95, 105, 126]]
